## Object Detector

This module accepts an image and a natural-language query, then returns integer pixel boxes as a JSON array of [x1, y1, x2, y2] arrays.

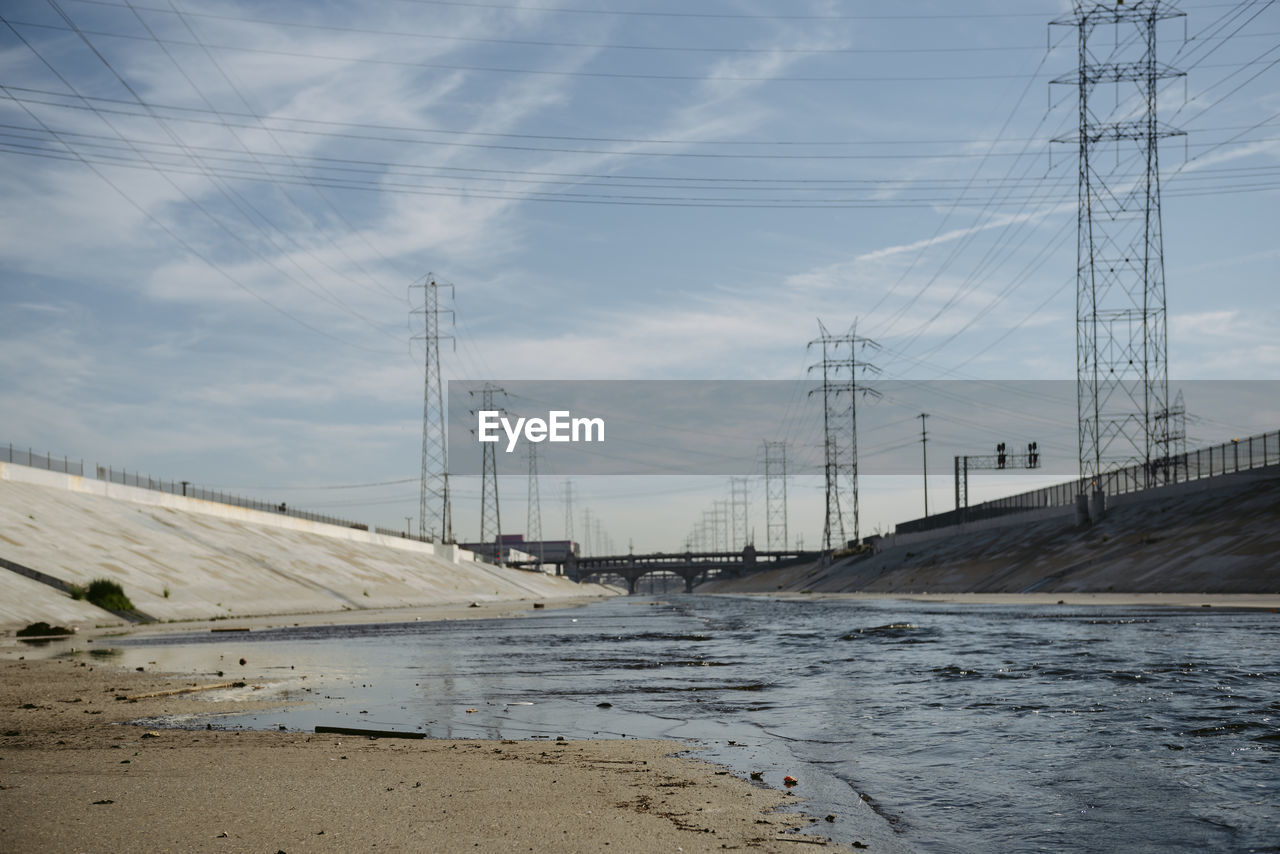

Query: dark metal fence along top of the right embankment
[[895, 430, 1280, 534]]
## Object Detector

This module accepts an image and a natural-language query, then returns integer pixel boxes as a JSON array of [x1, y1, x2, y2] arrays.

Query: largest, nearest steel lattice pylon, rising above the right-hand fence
[[1052, 0, 1184, 484]]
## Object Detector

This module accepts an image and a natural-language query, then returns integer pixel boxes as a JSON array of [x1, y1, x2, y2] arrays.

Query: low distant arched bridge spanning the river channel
[[508, 545, 822, 593]]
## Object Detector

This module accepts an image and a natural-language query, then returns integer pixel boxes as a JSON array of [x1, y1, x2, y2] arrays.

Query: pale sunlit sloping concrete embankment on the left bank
[[0, 462, 613, 627]]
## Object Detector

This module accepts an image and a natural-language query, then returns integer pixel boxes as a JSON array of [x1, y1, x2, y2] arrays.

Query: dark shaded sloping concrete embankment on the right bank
[[698, 466, 1280, 594]]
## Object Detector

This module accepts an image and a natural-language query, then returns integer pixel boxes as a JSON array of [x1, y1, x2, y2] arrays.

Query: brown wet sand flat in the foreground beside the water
[[0, 650, 852, 854]]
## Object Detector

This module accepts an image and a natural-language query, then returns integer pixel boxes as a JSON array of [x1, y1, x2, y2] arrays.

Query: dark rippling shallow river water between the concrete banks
[[113, 595, 1280, 854]]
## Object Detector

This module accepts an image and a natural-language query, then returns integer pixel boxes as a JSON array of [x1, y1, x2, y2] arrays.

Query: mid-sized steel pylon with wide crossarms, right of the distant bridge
[[809, 320, 879, 551]]
